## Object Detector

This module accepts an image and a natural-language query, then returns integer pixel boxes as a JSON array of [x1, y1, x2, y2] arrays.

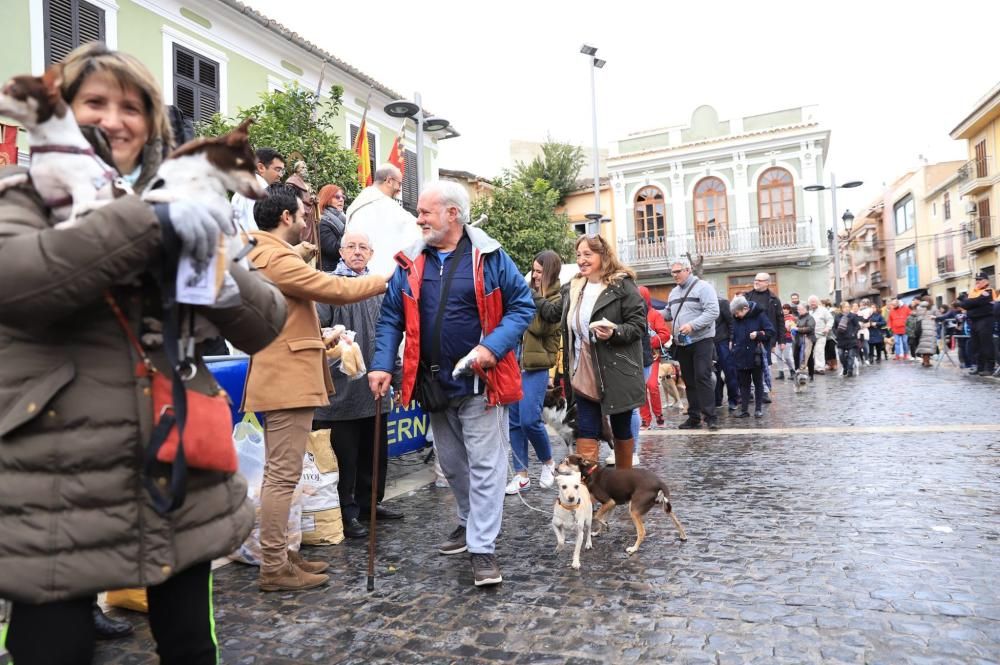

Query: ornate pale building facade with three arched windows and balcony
[[608, 106, 830, 299]]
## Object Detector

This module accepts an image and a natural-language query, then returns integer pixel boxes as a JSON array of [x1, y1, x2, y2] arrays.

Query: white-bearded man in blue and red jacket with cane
[[368, 181, 535, 586]]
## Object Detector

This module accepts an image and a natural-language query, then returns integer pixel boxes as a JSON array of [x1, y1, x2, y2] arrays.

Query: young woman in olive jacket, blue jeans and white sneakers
[[506, 249, 562, 494]]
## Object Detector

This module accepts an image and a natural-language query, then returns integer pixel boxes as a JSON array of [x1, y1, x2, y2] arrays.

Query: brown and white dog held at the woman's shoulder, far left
[[0, 65, 120, 228]]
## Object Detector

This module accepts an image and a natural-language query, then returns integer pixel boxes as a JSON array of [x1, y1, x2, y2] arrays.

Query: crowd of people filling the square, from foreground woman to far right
[[0, 44, 997, 664]]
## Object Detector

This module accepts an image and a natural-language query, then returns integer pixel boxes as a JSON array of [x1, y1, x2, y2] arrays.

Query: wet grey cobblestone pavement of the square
[[60, 361, 1000, 665]]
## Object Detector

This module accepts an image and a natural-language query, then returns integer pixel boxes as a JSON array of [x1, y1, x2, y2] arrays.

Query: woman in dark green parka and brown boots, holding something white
[[562, 235, 646, 469]]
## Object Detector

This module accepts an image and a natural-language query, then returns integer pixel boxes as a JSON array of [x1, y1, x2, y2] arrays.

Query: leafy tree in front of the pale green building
[[196, 85, 361, 199]]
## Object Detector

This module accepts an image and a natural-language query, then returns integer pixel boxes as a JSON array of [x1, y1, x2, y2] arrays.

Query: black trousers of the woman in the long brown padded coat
[[7, 561, 219, 665]]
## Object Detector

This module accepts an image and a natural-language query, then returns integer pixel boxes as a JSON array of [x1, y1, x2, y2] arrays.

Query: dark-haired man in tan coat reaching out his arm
[[242, 185, 387, 591]]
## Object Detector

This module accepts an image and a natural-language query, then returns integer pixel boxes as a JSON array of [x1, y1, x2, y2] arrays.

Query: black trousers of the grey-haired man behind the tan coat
[[313, 414, 389, 522]]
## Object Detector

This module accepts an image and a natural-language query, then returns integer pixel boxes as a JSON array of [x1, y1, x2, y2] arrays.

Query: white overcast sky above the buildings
[[244, 0, 1000, 209]]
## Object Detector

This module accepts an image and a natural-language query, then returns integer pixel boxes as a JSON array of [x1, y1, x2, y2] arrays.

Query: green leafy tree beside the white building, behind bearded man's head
[[472, 173, 573, 272]]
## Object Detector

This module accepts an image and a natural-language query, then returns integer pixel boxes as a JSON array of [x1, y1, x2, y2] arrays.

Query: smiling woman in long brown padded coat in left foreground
[[0, 42, 285, 665]]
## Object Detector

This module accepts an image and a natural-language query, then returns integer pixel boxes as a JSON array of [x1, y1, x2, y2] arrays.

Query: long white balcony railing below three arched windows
[[618, 220, 813, 266]]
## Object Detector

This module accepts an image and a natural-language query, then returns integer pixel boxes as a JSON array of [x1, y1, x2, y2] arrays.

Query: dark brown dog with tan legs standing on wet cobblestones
[[559, 454, 687, 554]]
